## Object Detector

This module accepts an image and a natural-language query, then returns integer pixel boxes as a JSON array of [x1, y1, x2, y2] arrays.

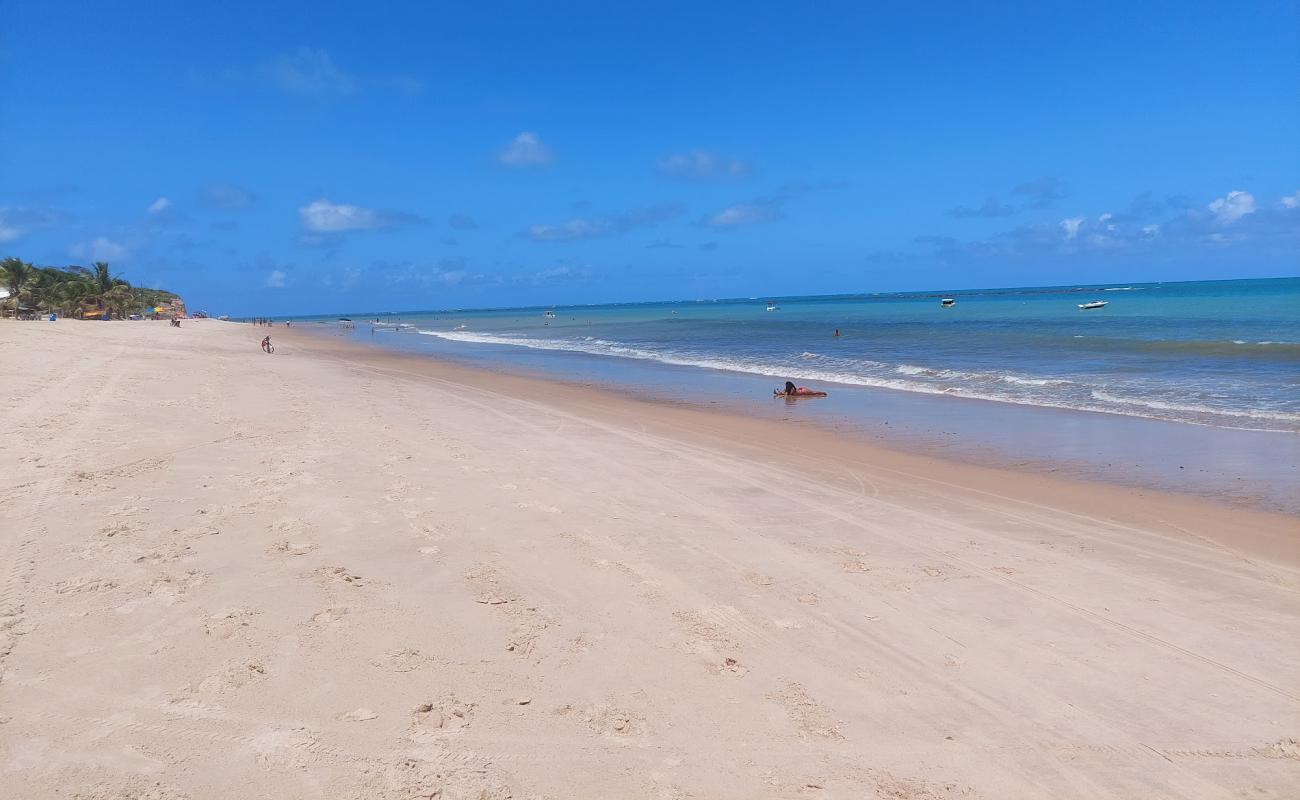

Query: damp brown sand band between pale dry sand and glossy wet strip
[[282, 318, 1300, 565]]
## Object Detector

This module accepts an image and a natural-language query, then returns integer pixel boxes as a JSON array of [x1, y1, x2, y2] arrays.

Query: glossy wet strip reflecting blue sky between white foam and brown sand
[[302, 313, 1300, 516]]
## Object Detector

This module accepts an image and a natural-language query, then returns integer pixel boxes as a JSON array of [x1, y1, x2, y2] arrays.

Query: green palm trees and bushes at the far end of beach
[[0, 256, 177, 319]]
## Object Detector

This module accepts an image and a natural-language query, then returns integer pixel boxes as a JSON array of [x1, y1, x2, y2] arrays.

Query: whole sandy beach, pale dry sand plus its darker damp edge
[[0, 320, 1300, 800]]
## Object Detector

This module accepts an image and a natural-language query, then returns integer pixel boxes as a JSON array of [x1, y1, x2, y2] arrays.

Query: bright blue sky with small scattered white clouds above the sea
[[0, 0, 1300, 316]]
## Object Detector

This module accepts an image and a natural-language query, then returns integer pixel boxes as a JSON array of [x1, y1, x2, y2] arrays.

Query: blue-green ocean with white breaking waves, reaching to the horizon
[[327, 278, 1300, 433]]
